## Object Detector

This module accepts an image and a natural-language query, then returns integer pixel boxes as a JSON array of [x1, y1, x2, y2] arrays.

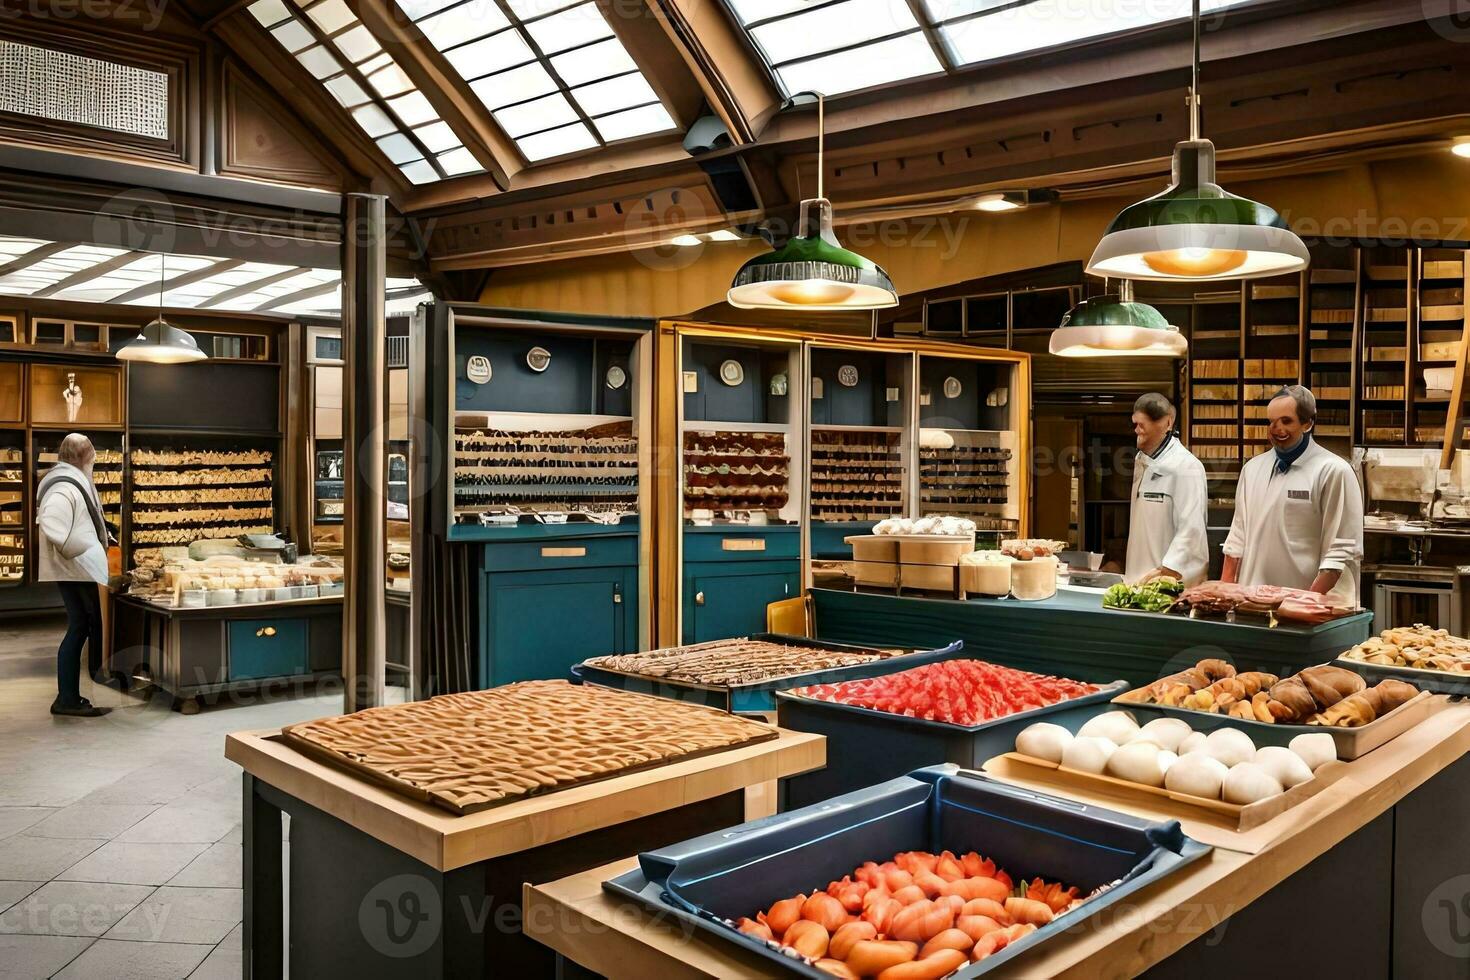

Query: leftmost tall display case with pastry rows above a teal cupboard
[[435, 306, 653, 688]]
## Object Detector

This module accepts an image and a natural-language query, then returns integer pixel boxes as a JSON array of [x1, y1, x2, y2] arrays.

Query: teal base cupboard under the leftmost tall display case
[[476, 525, 638, 688]]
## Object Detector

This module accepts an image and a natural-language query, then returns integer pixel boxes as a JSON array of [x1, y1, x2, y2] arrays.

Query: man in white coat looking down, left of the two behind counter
[[1125, 392, 1210, 585]]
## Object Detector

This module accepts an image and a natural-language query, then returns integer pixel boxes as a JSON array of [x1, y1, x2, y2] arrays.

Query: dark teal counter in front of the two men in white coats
[[811, 589, 1373, 686]]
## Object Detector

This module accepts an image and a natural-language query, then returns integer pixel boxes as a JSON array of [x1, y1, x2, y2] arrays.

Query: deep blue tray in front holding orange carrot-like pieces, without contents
[[603, 765, 1210, 980]]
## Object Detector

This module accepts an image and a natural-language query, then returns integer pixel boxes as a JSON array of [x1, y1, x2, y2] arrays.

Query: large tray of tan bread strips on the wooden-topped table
[[281, 680, 778, 815]]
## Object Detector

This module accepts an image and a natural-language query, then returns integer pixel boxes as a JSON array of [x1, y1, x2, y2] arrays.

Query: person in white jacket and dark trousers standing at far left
[[35, 432, 109, 718]]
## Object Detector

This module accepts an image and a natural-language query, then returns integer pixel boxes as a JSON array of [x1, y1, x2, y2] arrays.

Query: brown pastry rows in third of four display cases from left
[[807, 425, 906, 523]]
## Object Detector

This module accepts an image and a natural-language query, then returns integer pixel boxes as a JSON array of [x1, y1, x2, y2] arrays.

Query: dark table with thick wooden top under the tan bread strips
[[225, 730, 826, 980]]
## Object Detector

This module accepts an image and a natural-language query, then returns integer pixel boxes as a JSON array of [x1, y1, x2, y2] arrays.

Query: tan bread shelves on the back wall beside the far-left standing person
[[128, 445, 275, 564]]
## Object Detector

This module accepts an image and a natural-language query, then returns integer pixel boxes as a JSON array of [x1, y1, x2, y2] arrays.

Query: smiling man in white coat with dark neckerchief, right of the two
[[1220, 385, 1363, 605]]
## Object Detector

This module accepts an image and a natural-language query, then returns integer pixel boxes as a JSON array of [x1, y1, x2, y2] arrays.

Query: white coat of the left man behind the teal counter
[[1125, 435, 1210, 585]]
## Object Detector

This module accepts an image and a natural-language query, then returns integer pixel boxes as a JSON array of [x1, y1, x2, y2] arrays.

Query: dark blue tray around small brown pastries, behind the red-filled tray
[[572, 633, 964, 714]]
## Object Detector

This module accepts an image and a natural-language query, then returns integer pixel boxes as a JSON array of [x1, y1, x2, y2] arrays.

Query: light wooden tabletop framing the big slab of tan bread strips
[[225, 729, 826, 871]]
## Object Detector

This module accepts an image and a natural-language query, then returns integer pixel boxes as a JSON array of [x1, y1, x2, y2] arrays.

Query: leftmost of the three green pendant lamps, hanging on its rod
[[725, 93, 898, 310]]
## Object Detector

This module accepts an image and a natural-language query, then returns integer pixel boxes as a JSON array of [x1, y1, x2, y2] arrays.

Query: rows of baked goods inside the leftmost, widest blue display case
[[454, 411, 638, 523]]
